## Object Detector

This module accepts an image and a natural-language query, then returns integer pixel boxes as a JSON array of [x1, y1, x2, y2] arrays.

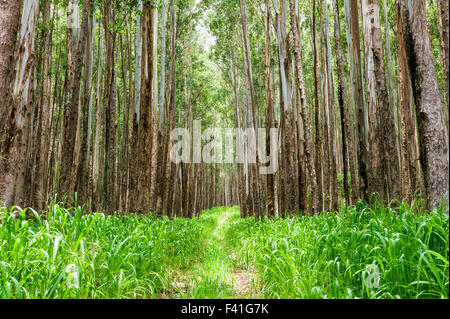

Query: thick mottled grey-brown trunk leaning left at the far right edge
[[400, 0, 449, 208]]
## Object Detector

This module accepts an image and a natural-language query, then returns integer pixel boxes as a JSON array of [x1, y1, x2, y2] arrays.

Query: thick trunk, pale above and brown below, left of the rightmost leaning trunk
[[362, 0, 401, 201]]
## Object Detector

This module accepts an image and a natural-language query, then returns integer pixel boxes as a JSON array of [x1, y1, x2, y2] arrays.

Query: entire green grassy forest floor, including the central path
[[0, 203, 449, 299]]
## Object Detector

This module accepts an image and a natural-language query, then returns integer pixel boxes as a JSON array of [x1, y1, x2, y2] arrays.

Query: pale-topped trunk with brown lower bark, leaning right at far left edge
[[0, 0, 39, 207]]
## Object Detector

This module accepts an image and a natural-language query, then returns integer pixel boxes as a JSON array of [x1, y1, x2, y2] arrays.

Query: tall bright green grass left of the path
[[0, 203, 202, 298]]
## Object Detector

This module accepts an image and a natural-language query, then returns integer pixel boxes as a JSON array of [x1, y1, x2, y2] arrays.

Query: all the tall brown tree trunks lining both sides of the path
[[0, 0, 448, 219]]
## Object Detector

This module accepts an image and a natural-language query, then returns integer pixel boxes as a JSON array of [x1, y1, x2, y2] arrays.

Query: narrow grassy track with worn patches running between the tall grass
[[166, 208, 260, 299]]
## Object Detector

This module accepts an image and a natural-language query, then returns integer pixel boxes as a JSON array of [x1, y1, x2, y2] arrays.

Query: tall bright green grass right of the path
[[226, 203, 449, 299]]
